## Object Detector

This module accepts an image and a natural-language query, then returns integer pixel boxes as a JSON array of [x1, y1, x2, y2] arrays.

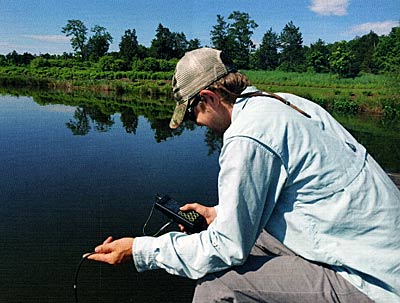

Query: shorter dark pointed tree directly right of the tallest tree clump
[[254, 28, 279, 70]]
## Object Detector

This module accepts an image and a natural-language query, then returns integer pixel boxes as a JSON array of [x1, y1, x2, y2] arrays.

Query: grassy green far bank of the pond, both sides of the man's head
[[0, 66, 400, 116]]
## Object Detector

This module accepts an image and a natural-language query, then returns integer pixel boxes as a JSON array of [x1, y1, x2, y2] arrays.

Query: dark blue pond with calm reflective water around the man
[[0, 95, 400, 302]]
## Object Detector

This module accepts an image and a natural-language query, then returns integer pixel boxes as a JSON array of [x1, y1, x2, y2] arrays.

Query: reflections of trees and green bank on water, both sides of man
[[0, 90, 400, 172]]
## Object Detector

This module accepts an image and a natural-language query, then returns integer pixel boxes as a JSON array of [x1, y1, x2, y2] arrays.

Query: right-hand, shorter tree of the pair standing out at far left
[[87, 25, 113, 61]]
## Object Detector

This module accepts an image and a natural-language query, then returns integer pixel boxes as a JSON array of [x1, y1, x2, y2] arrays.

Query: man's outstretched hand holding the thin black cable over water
[[84, 237, 134, 265]]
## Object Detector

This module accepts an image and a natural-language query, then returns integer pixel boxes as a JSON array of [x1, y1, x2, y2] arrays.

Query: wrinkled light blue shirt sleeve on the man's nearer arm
[[132, 137, 286, 279]]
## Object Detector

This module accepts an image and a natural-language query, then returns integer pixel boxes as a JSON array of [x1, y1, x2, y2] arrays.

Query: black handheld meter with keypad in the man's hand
[[154, 195, 206, 233]]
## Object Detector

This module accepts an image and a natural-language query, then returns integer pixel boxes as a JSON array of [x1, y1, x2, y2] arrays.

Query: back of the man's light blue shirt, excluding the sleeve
[[224, 87, 400, 301]]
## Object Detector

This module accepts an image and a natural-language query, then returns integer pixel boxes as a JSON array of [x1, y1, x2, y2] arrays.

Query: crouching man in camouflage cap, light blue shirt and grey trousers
[[90, 48, 400, 302]]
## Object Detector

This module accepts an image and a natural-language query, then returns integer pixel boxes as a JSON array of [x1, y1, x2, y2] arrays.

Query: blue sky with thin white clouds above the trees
[[0, 0, 400, 54]]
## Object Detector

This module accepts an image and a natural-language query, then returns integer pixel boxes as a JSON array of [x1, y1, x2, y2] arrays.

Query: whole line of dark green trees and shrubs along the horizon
[[0, 11, 400, 77]]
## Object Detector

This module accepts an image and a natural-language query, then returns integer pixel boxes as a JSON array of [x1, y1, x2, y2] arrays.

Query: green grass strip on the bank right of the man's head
[[243, 71, 400, 115]]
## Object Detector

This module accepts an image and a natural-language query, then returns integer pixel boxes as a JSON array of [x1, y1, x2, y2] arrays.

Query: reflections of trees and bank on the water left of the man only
[[29, 91, 222, 150]]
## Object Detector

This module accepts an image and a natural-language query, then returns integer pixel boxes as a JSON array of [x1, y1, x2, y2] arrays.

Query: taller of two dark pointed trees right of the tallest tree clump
[[279, 21, 304, 72]]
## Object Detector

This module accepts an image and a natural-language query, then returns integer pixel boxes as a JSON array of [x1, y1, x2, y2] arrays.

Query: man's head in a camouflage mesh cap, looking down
[[170, 48, 249, 132]]
